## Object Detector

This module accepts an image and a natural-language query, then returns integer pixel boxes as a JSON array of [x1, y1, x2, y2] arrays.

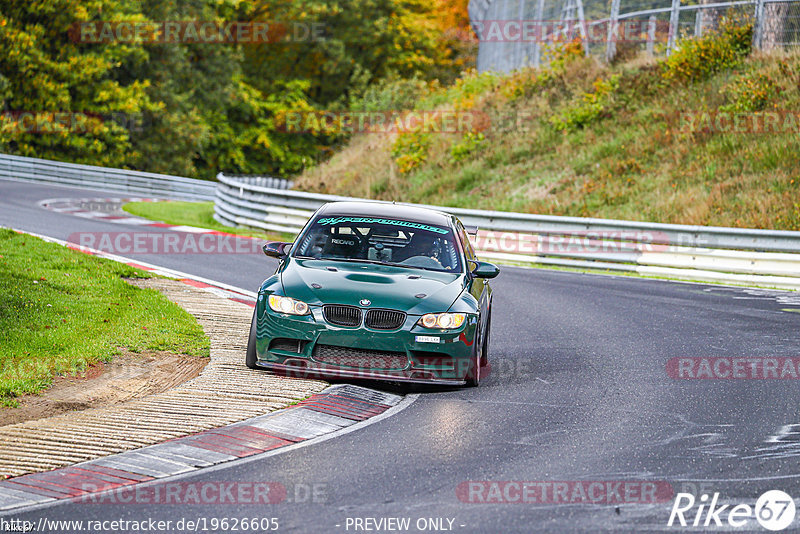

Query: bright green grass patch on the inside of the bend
[[0, 228, 209, 406]]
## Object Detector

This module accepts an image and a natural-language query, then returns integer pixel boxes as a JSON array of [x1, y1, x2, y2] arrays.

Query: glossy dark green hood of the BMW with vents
[[281, 258, 465, 315]]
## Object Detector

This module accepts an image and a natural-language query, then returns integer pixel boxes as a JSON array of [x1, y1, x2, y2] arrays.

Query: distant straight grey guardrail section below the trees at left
[[0, 154, 216, 201]]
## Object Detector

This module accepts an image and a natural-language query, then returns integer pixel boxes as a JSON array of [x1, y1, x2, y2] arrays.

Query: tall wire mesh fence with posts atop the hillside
[[469, 0, 800, 72]]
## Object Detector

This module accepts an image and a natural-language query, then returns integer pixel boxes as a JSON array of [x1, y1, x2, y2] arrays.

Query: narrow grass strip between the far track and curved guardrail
[[122, 201, 294, 241]]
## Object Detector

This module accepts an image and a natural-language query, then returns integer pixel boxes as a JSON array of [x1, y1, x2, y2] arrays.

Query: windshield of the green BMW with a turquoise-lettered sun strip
[[292, 216, 461, 272]]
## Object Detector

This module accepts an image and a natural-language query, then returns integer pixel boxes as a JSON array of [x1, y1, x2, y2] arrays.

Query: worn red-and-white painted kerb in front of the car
[[0, 384, 403, 511]]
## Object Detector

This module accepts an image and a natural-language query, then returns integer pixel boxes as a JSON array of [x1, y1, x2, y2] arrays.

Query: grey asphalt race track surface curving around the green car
[[0, 181, 800, 532]]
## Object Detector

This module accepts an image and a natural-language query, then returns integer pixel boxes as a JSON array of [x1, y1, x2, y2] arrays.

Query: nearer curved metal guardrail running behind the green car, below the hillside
[[214, 174, 800, 289]]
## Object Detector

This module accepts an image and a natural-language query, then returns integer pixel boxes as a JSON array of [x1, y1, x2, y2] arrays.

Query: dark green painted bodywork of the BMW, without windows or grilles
[[250, 203, 496, 385]]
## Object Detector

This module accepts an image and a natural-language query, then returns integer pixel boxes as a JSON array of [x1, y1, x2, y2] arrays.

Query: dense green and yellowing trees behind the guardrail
[[0, 0, 467, 179]]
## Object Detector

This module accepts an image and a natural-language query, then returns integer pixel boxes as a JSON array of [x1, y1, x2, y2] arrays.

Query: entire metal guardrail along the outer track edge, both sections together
[[0, 154, 800, 289]]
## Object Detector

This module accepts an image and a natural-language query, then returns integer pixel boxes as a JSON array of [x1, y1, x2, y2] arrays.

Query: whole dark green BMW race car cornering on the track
[[246, 202, 499, 386]]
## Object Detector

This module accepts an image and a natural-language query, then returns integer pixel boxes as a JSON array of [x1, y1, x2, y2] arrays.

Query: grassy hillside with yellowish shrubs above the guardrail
[[297, 24, 800, 230]]
